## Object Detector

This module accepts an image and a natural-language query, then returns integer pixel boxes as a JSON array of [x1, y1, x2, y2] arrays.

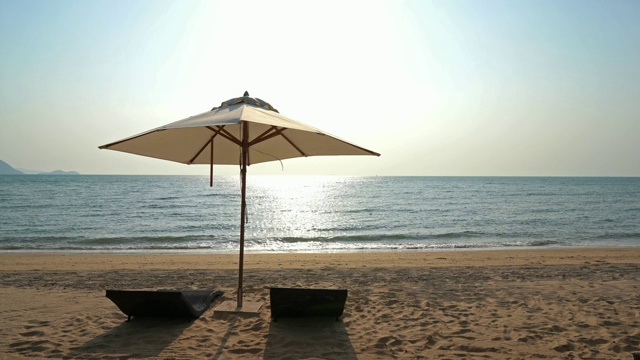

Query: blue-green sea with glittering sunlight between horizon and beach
[[0, 174, 640, 253]]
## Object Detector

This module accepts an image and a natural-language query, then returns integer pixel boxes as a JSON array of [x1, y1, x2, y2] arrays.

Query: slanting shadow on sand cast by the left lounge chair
[[68, 318, 193, 359]]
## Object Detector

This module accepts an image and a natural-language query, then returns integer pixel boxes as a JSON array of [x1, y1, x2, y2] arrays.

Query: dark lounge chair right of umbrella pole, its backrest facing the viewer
[[269, 288, 347, 321]]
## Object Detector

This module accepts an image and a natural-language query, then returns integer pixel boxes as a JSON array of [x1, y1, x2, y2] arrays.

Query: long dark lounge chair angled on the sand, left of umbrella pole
[[107, 290, 224, 321]]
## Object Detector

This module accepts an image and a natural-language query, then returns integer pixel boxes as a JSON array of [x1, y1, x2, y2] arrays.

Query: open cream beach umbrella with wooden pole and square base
[[99, 92, 380, 312]]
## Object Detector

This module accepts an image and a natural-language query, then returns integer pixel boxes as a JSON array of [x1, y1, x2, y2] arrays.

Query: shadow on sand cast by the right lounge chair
[[264, 317, 358, 360]]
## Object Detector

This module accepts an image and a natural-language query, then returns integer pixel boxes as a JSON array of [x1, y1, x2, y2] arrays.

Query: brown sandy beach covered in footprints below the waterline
[[0, 248, 640, 359]]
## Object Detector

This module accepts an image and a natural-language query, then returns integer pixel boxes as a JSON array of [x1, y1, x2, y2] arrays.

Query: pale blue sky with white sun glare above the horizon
[[0, 0, 640, 176]]
